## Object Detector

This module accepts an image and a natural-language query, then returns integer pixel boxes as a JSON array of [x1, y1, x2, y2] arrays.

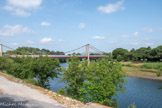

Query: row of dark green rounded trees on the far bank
[[112, 45, 162, 62]]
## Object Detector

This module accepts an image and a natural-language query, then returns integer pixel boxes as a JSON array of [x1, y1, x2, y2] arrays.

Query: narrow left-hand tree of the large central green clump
[[62, 57, 88, 99]]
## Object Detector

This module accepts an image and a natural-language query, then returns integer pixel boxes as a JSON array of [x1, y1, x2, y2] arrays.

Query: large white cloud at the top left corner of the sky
[[4, 0, 42, 17]]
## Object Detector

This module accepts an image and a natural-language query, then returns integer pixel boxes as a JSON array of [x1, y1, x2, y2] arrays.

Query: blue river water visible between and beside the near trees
[[50, 63, 162, 108]]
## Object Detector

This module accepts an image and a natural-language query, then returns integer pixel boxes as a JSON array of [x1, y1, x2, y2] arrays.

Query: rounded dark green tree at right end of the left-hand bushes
[[34, 56, 60, 88]]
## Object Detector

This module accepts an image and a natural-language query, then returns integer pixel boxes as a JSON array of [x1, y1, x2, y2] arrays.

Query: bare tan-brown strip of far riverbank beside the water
[[123, 66, 162, 81]]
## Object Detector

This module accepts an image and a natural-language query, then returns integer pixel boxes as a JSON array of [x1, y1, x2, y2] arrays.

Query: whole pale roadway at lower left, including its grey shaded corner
[[0, 76, 65, 108]]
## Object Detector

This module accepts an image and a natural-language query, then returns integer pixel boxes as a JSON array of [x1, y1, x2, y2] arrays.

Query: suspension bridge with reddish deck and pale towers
[[0, 44, 104, 62]]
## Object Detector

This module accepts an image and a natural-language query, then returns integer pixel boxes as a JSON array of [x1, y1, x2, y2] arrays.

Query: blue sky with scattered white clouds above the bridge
[[0, 0, 162, 52]]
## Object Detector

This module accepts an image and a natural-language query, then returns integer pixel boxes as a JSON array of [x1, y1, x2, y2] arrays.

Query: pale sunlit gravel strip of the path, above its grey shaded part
[[0, 76, 66, 108]]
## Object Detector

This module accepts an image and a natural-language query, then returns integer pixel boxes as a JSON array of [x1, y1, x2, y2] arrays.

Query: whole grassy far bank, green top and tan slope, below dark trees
[[121, 62, 162, 80]]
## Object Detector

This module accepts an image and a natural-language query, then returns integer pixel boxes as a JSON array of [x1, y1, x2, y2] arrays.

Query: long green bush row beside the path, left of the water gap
[[0, 56, 60, 88]]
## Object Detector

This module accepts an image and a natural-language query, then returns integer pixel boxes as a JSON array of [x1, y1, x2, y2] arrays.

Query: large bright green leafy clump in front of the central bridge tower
[[61, 57, 126, 106]]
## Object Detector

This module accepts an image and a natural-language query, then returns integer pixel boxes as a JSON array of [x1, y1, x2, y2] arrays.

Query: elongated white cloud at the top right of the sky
[[98, 0, 125, 14]]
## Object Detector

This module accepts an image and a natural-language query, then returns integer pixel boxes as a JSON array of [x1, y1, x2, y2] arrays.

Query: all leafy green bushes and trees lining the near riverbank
[[0, 56, 126, 106]]
